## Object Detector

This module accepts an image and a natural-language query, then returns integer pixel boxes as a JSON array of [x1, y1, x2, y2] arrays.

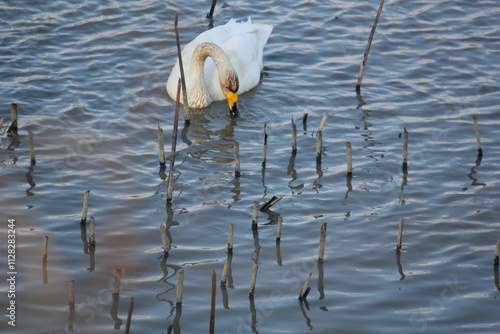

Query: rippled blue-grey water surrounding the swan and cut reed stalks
[[0, 0, 500, 334]]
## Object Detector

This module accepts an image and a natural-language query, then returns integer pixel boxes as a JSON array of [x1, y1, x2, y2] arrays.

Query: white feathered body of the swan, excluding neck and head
[[167, 18, 273, 105]]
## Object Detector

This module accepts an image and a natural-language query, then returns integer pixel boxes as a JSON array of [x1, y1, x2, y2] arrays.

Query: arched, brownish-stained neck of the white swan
[[188, 42, 238, 108]]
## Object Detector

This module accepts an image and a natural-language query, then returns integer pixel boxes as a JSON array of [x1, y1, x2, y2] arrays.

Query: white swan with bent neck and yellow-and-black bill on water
[[167, 18, 273, 113]]
